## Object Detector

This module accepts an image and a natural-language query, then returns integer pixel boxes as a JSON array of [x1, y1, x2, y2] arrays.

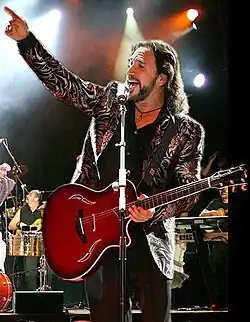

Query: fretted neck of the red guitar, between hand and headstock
[[133, 178, 211, 209]]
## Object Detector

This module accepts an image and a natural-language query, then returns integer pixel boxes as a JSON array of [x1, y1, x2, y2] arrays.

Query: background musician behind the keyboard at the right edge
[[200, 187, 229, 308]]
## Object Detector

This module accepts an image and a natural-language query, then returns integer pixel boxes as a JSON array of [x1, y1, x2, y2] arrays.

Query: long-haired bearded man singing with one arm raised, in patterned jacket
[[5, 7, 204, 322]]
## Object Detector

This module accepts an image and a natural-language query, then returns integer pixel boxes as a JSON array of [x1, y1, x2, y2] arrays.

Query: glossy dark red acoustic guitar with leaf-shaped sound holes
[[42, 166, 245, 280]]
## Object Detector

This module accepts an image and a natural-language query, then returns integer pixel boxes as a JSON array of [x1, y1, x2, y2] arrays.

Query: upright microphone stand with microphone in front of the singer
[[116, 91, 127, 322]]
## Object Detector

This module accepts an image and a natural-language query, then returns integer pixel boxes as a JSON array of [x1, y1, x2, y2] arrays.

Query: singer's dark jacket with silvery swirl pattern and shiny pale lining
[[18, 33, 204, 278]]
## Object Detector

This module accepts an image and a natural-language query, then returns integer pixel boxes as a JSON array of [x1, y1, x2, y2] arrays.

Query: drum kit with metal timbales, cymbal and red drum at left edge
[[0, 138, 51, 313]]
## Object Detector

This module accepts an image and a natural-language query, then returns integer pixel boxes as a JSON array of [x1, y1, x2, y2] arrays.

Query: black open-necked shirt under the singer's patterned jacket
[[98, 102, 158, 189]]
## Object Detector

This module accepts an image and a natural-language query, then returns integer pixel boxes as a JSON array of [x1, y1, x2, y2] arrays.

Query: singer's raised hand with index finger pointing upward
[[4, 7, 29, 40]]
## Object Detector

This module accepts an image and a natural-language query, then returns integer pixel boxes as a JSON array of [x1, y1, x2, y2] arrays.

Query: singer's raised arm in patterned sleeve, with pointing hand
[[4, 7, 113, 117]]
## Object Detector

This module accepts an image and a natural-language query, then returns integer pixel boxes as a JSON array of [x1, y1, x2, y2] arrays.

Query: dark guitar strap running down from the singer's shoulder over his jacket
[[141, 116, 180, 187]]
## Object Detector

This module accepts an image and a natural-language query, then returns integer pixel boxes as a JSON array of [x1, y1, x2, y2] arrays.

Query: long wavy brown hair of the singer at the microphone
[[131, 40, 190, 115]]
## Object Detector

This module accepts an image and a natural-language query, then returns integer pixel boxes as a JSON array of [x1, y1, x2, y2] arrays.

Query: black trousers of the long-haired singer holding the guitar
[[86, 226, 171, 322]]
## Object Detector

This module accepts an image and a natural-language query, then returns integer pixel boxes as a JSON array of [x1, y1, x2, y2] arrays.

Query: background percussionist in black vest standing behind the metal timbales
[[8, 190, 51, 290]]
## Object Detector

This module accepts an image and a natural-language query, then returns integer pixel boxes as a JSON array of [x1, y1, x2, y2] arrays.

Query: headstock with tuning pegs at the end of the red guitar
[[210, 164, 247, 191]]
